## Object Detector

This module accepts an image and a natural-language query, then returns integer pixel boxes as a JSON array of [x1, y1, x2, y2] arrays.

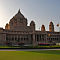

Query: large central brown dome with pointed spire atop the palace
[[9, 9, 27, 29]]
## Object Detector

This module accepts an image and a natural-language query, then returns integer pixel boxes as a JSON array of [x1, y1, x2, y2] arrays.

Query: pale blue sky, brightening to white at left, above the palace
[[0, 0, 60, 31]]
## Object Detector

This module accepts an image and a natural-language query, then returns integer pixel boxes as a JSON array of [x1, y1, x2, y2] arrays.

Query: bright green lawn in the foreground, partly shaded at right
[[0, 50, 60, 60]]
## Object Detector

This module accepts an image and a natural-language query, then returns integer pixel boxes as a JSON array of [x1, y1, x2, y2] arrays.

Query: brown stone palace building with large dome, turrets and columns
[[0, 10, 60, 46]]
